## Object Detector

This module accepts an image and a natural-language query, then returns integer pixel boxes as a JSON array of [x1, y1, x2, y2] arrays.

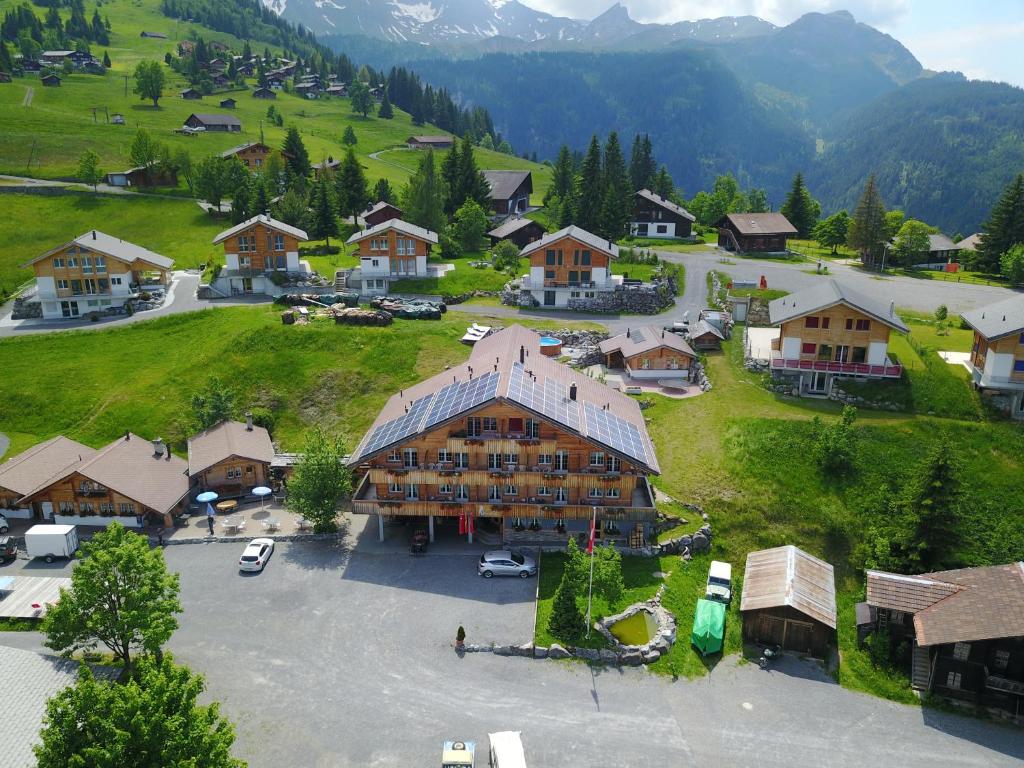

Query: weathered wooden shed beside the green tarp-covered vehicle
[[739, 544, 836, 657]]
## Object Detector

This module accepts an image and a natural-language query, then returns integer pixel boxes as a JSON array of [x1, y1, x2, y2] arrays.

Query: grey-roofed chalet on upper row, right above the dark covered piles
[[346, 219, 437, 296]]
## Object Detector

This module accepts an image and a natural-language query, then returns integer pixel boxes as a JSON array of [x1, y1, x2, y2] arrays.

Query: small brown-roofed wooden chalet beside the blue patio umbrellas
[[188, 416, 273, 499]]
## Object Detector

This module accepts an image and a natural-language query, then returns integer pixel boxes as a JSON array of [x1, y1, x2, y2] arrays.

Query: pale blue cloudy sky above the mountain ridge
[[520, 0, 1024, 87]]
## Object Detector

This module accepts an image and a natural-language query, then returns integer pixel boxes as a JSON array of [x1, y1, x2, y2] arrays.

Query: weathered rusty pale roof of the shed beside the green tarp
[[739, 544, 836, 629]]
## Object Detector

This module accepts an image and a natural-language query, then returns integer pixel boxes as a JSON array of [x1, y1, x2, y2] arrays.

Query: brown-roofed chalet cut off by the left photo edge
[[0, 435, 96, 519]]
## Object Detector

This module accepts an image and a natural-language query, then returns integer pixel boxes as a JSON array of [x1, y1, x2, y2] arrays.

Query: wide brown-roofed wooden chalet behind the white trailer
[[17, 432, 188, 526]]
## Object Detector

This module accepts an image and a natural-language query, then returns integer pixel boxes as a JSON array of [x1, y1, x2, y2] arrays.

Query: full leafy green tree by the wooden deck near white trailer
[[43, 522, 181, 670]]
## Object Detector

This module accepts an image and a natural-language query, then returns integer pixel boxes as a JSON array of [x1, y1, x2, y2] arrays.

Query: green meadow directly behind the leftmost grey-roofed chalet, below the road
[[0, 193, 224, 289]]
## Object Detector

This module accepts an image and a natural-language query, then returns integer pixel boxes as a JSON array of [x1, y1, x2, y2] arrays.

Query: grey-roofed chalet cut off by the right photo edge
[[961, 296, 1024, 419]]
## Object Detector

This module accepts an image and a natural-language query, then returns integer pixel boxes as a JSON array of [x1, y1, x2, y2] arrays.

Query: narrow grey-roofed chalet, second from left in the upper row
[[210, 213, 309, 296]]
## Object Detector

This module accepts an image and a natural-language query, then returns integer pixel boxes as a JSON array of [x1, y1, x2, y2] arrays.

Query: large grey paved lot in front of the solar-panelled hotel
[[6, 542, 1024, 768]]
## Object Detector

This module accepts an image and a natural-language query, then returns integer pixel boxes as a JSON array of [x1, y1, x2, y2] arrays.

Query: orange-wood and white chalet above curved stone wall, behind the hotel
[[519, 226, 623, 307]]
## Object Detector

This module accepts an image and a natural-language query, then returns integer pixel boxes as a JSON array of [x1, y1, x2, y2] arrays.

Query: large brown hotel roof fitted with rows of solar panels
[[349, 326, 660, 473]]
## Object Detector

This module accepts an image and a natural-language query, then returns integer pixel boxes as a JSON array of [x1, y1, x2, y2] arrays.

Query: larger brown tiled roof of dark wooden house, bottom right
[[913, 562, 1024, 645]]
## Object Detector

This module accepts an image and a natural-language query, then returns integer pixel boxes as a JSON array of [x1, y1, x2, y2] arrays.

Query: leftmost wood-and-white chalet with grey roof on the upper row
[[23, 229, 174, 319]]
